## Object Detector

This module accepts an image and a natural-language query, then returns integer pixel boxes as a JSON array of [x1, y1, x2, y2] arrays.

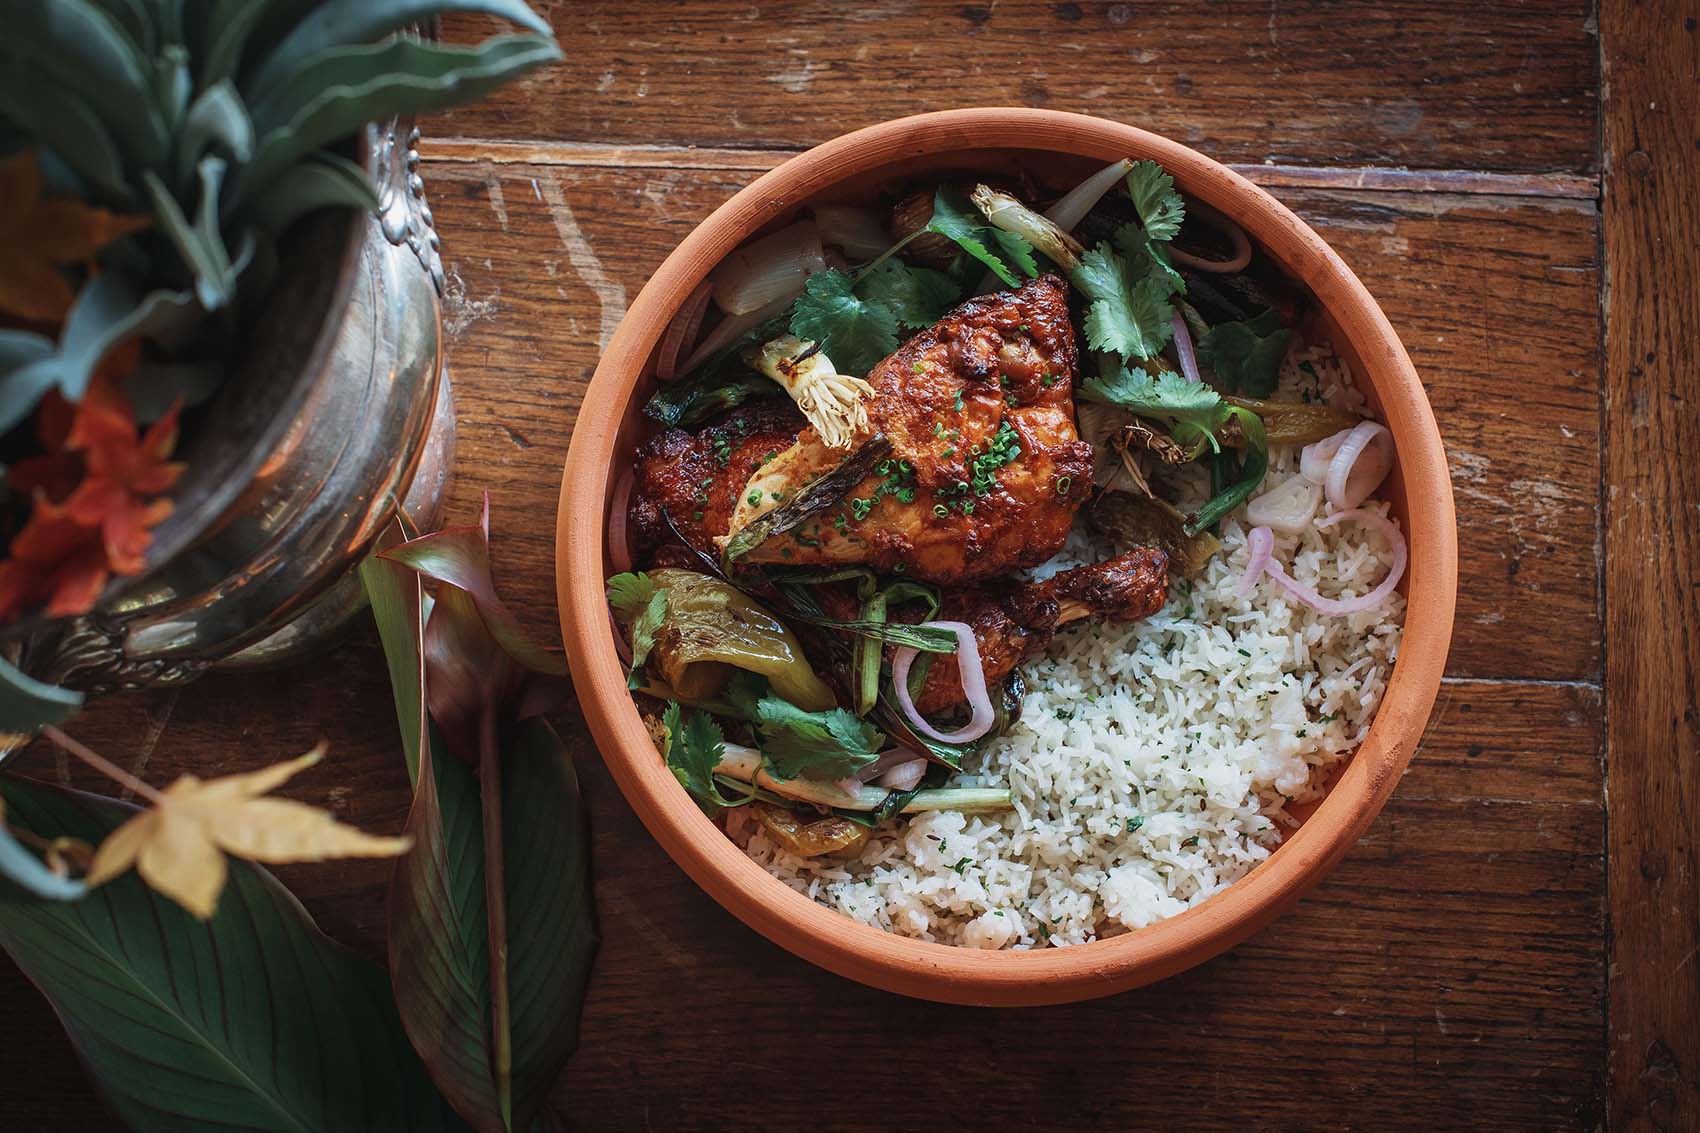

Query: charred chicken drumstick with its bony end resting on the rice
[[915, 546, 1168, 716]]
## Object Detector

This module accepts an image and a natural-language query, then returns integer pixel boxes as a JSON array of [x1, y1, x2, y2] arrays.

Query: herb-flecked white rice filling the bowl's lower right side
[[728, 347, 1404, 948]]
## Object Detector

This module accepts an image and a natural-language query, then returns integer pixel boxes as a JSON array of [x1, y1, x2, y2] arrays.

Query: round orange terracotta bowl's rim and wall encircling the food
[[556, 109, 1457, 1005]]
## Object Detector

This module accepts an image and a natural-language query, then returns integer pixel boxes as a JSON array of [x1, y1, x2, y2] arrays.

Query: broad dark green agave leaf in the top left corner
[[0, 0, 168, 165]]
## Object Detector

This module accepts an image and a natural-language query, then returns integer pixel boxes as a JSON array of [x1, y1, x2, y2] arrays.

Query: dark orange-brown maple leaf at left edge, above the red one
[[0, 150, 150, 323]]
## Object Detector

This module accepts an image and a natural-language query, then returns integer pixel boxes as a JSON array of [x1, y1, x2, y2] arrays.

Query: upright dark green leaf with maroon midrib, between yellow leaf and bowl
[[362, 529, 597, 1130]]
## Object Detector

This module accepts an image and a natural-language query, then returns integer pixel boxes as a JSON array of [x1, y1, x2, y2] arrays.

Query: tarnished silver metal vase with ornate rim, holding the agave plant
[[0, 122, 454, 694]]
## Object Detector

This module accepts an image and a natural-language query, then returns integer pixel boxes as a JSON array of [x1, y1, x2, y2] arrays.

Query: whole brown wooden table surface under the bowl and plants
[[0, 0, 1700, 1131]]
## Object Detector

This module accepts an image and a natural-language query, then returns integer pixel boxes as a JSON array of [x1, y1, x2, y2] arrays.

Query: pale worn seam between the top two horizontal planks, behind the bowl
[[423, 138, 1600, 201]]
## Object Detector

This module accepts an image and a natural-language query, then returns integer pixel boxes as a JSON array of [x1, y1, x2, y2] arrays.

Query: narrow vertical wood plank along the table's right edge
[[1600, 0, 1700, 1130]]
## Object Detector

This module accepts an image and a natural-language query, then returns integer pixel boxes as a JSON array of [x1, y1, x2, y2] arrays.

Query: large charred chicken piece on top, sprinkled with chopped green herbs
[[721, 276, 1093, 585]]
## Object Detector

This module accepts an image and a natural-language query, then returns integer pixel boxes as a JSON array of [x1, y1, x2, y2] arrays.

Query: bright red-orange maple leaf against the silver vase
[[0, 358, 184, 619]]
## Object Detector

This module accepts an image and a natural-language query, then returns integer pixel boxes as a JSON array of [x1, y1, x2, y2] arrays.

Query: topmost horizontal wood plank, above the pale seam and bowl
[[435, 0, 1596, 172]]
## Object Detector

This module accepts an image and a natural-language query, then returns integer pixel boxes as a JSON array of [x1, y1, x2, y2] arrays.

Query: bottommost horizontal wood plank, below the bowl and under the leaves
[[0, 670, 1605, 1130]]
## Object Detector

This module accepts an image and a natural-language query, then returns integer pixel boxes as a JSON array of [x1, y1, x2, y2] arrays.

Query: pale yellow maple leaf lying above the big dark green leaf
[[87, 743, 411, 920]]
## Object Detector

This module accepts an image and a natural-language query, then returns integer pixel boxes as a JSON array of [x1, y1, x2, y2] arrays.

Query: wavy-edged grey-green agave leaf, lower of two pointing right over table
[[243, 36, 561, 185]]
